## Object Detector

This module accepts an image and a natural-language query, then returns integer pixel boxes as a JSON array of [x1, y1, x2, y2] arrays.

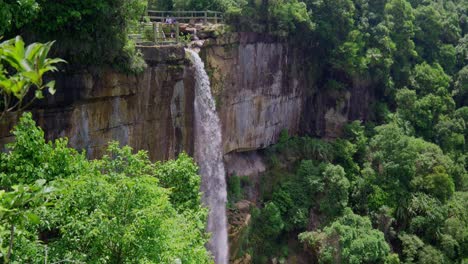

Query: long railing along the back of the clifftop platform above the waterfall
[[147, 10, 223, 24]]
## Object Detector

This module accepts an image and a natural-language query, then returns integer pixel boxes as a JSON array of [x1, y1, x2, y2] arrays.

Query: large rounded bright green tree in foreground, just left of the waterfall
[[44, 148, 209, 263]]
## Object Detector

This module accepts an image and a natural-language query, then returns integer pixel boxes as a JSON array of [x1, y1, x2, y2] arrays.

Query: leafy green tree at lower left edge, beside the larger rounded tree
[[0, 113, 80, 263]]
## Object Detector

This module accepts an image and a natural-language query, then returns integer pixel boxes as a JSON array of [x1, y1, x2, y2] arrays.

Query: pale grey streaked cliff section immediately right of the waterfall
[[203, 34, 307, 153]]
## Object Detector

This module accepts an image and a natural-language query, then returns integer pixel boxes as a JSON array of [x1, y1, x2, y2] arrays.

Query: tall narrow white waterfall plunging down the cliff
[[186, 49, 229, 264]]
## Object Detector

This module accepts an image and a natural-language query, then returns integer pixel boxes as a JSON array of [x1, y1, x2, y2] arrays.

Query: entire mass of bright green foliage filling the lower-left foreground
[[0, 114, 212, 263]]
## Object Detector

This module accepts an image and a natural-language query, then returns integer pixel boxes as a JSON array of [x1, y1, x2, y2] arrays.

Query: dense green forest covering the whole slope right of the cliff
[[236, 0, 468, 263]]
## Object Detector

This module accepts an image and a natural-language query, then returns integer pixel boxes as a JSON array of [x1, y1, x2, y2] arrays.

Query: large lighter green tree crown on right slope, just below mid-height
[[369, 124, 453, 211]]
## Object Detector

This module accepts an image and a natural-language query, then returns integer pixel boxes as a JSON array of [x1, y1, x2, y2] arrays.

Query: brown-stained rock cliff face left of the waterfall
[[0, 48, 194, 160]]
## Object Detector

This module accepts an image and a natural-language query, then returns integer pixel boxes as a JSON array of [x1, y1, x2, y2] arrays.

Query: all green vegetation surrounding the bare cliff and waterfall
[[0, 0, 468, 264]]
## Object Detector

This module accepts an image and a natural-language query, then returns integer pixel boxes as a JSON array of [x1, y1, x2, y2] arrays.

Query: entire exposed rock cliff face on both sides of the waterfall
[[0, 33, 370, 160]]
